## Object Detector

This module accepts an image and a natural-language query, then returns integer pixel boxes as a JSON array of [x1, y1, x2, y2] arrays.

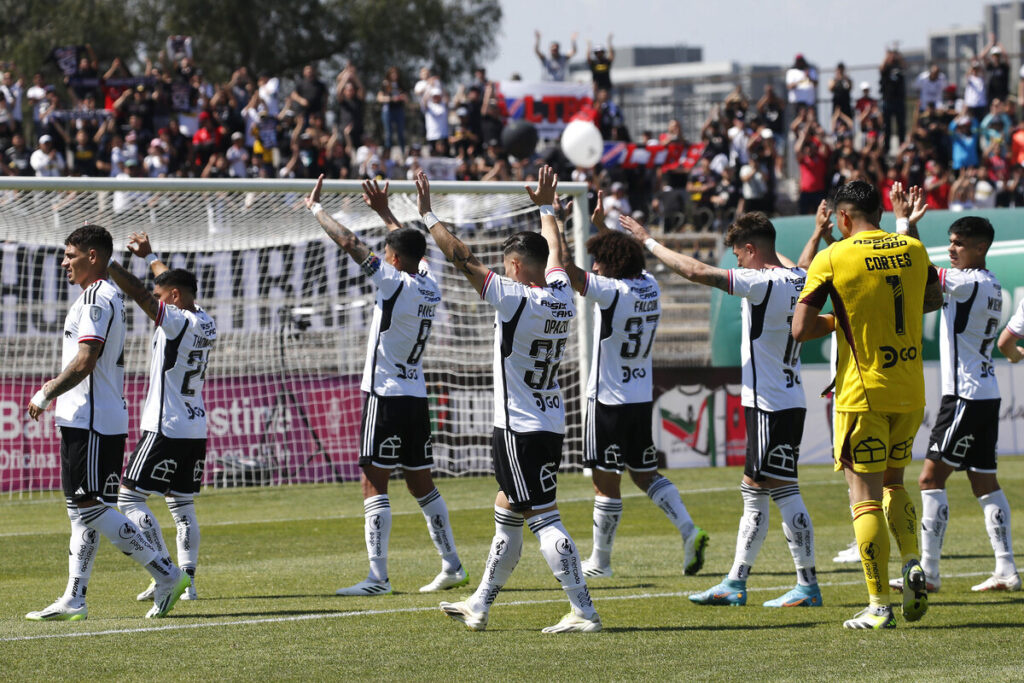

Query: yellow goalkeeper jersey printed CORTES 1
[[800, 230, 938, 413]]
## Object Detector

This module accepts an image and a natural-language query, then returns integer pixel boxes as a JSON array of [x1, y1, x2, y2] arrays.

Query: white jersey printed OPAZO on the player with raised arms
[[480, 268, 575, 434]]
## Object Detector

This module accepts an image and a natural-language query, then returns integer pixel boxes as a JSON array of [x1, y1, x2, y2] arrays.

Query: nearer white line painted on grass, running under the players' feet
[[0, 571, 988, 643]]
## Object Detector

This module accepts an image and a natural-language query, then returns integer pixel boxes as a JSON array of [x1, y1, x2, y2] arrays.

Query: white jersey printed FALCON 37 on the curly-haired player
[[583, 271, 662, 405]]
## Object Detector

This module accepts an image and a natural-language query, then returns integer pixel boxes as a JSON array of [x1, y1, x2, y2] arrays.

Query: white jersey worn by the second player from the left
[[141, 301, 217, 438]]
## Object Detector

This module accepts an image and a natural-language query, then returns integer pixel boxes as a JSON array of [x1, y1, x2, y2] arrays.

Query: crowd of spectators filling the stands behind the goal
[[6, 32, 1024, 224]]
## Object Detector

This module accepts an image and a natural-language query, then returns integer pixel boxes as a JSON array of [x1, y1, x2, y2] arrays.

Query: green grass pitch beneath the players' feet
[[0, 458, 1024, 681]]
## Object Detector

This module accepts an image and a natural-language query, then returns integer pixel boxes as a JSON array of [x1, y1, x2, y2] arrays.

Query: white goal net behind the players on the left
[[0, 178, 590, 494]]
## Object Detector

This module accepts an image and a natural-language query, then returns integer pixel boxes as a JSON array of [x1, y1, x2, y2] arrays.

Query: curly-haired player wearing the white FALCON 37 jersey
[[559, 193, 709, 578]]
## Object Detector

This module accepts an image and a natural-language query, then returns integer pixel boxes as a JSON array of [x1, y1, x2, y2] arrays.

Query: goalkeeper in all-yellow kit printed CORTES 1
[[793, 181, 942, 629]]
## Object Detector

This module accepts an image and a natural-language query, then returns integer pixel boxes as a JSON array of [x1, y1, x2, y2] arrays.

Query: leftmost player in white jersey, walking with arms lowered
[[25, 225, 188, 622]]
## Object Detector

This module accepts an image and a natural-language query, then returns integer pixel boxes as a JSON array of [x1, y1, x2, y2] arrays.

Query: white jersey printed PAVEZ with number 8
[[362, 255, 441, 397]]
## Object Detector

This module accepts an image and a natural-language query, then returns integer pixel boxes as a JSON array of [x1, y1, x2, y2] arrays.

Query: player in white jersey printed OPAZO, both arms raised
[[416, 166, 601, 633]]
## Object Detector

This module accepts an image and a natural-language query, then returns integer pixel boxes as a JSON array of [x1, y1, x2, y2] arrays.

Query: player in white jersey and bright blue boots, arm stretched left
[[620, 212, 821, 607]]
